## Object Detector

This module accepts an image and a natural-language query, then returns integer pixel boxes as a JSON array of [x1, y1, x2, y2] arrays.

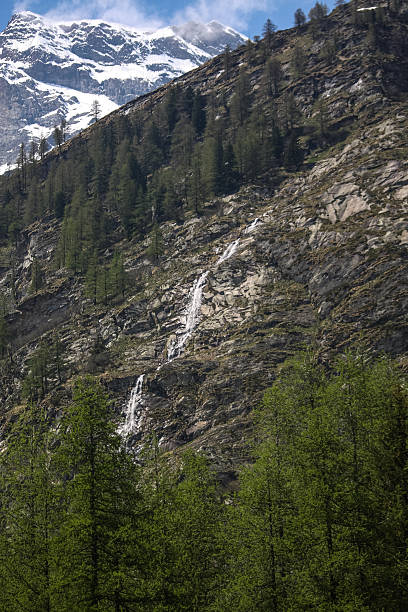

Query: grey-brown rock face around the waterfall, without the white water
[[3, 119, 408, 469]]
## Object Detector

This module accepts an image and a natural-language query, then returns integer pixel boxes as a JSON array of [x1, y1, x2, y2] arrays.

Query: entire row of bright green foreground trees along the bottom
[[0, 353, 408, 612]]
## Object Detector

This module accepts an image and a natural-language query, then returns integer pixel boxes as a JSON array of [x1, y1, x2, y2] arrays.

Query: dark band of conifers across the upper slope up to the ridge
[[0, 15, 372, 284]]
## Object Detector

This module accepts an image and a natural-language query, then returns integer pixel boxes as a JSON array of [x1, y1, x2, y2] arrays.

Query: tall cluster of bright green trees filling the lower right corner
[[221, 355, 408, 611]]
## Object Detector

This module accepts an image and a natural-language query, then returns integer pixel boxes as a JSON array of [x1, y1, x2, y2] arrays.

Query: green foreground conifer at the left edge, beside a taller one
[[0, 406, 58, 612]]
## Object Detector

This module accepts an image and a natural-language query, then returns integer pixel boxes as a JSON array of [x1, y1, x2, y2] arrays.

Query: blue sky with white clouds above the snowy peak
[[0, 0, 332, 37]]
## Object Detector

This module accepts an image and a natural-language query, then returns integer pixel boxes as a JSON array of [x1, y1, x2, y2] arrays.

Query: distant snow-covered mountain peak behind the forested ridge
[[0, 11, 245, 170]]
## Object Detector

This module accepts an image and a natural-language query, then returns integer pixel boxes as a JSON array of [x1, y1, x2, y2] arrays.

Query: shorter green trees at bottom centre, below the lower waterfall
[[145, 452, 224, 612]]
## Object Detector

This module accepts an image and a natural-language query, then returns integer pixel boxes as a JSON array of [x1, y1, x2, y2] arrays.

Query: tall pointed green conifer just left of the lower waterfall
[[55, 378, 140, 612]]
